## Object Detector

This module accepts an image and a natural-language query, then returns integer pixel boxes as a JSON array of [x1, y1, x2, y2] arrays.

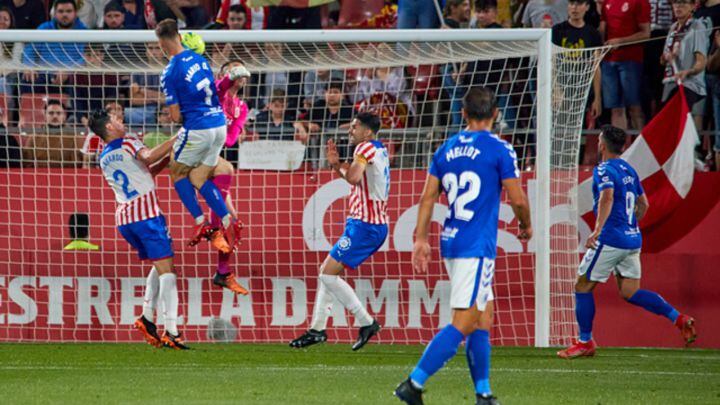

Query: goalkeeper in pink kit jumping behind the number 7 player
[[210, 60, 250, 295]]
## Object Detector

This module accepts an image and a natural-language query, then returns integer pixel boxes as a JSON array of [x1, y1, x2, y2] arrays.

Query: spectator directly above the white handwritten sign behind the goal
[[253, 89, 296, 141]]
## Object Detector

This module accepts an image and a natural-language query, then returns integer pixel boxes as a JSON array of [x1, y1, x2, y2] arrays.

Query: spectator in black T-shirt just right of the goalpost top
[[552, 0, 602, 119]]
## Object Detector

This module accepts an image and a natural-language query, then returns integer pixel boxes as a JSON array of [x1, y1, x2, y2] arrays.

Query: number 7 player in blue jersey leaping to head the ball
[[155, 19, 236, 253]]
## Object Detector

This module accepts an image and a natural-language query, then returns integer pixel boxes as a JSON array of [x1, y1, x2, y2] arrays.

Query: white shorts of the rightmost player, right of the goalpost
[[578, 245, 641, 283]]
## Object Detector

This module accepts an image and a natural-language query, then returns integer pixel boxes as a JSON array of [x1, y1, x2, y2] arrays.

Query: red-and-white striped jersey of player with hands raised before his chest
[[350, 139, 390, 224]]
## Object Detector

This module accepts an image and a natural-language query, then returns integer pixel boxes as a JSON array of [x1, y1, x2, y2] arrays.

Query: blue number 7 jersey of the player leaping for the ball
[[160, 50, 225, 130]]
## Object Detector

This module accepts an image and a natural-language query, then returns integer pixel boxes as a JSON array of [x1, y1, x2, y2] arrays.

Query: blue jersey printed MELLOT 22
[[430, 131, 520, 259]]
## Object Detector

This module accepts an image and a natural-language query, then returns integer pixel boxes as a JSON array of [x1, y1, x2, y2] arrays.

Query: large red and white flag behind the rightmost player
[[578, 86, 698, 229]]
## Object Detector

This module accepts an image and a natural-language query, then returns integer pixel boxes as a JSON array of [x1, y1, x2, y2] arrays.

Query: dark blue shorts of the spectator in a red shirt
[[600, 61, 643, 108]]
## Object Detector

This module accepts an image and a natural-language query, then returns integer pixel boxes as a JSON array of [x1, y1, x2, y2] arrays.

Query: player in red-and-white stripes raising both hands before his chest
[[290, 113, 390, 350]]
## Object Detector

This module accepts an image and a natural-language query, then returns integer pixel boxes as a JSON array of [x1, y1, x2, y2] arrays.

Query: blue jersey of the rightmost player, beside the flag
[[593, 159, 644, 249]]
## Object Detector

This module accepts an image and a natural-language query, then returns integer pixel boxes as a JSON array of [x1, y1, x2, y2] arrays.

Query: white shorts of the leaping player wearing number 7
[[173, 125, 227, 167]]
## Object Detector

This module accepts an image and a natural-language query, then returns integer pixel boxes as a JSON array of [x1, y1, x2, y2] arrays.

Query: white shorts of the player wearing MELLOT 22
[[445, 257, 495, 311]]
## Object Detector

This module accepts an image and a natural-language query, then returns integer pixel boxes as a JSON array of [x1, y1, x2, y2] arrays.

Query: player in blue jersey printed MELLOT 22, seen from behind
[[395, 87, 532, 405]]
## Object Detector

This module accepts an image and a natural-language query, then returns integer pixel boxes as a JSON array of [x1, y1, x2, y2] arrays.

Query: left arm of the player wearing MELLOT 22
[[412, 174, 440, 273]]
